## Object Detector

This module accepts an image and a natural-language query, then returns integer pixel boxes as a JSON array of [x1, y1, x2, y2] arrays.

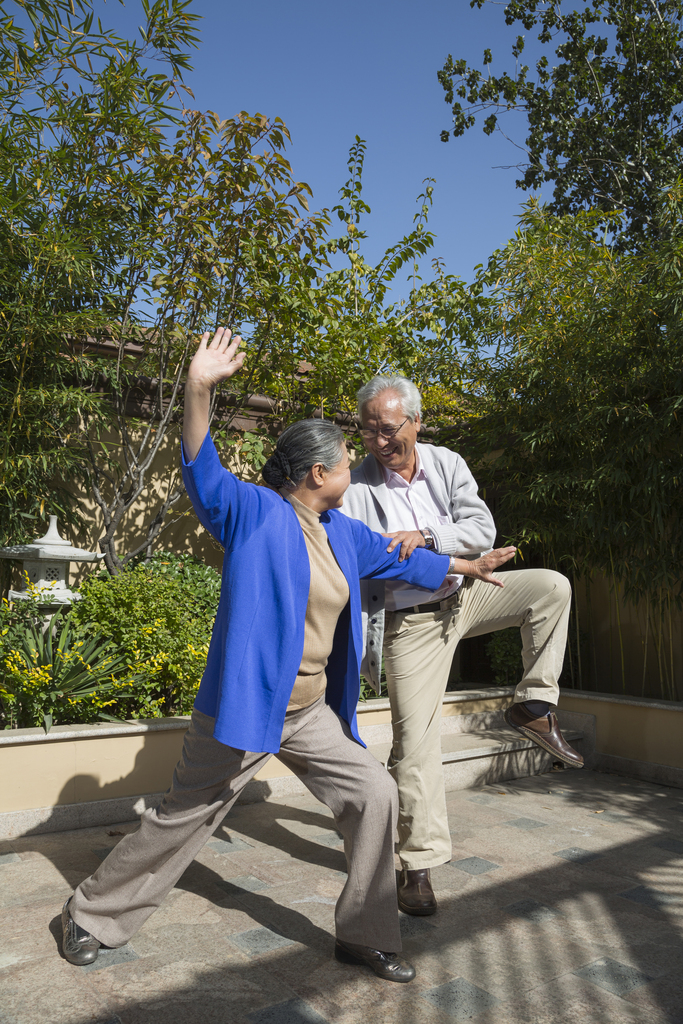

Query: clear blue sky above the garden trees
[[167, 0, 548, 297]]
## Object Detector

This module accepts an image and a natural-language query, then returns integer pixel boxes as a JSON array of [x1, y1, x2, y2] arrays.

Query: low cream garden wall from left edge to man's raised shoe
[[0, 687, 512, 838]]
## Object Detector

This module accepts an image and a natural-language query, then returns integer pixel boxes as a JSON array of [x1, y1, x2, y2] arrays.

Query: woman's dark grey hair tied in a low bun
[[261, 420, 344, 487]]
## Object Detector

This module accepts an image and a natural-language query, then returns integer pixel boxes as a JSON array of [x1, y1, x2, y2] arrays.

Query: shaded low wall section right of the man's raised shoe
[[560, 690, 683, 768]]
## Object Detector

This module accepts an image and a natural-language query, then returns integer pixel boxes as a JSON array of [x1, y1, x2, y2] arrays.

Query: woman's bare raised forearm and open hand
[[182, 327, 246, 462]]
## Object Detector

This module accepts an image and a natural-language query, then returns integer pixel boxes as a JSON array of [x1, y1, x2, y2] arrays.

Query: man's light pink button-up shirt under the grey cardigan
[[382, 447, 463, 611]]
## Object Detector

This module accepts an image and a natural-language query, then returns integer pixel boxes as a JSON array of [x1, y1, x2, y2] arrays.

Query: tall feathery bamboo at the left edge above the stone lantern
[[0, 0, 201, 569]]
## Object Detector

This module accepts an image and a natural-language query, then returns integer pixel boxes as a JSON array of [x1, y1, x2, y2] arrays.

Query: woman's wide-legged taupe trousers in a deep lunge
[[70, 697, 401, 951]]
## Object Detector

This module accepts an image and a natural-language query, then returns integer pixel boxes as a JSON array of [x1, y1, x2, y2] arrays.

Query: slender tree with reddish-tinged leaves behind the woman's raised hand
[[80, 112, 326, 573]]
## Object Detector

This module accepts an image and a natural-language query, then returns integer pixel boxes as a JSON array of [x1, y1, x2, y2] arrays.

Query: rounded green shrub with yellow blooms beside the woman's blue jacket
[[72, 552, 220, 718]]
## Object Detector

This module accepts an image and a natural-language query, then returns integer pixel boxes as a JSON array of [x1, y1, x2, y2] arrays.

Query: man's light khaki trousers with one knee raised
[[384, 569, 571, 869]]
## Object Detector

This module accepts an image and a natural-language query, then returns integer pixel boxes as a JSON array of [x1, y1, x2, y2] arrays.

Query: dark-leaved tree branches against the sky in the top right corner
[[438, 0, 683, 239]]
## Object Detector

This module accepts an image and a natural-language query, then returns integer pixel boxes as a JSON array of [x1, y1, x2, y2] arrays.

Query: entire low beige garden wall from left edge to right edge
[[0, 687, 683, 838]]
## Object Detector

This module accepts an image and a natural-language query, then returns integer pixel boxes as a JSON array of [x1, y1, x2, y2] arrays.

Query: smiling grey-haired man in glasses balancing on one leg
[[343, 376, 583, 915]]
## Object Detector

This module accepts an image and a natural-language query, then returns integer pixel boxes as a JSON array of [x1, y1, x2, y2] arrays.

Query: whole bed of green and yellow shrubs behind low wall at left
[[0, 552, 220, 729]]
